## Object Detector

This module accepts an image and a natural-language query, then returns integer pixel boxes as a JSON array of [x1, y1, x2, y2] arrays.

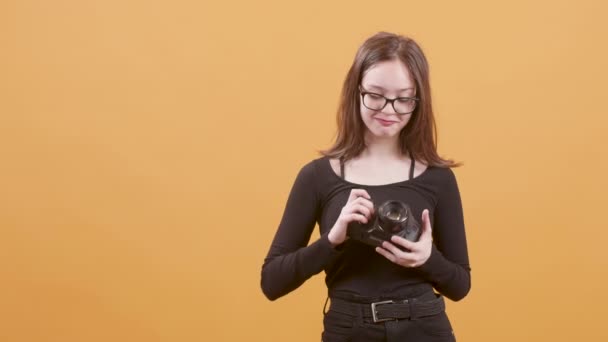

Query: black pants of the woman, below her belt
[[321, 292, 456, 342]]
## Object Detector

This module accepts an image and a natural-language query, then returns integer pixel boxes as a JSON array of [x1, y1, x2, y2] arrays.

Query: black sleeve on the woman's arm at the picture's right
[[418, 169, 471, 301]]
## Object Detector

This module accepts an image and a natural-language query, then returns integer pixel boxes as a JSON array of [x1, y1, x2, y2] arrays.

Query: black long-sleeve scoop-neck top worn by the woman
[[261, 157, 471, 301]]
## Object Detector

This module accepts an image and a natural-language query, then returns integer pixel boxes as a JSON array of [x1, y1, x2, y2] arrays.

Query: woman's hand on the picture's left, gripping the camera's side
[[327, 189, 374, 247]]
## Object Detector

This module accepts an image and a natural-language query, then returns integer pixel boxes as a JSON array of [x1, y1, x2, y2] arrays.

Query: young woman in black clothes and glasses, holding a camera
[[262, 32, 471, 342]]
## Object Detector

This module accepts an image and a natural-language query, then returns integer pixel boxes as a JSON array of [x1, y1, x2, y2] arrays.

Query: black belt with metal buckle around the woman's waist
[[330, 293, 445, 323]]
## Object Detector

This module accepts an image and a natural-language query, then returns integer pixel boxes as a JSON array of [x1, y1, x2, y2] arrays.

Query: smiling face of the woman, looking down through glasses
[[359, 59, 416, 138]]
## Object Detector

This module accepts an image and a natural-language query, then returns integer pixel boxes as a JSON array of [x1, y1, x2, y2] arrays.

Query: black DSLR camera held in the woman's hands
[[346, 201, 422, 247]]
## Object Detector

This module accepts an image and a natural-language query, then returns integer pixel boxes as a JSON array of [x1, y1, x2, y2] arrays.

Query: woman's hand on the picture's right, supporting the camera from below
[[376, 209, 433, 267]]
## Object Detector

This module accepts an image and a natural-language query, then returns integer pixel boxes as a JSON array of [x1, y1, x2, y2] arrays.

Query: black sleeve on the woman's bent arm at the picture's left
[[261, 162, 339, 300]]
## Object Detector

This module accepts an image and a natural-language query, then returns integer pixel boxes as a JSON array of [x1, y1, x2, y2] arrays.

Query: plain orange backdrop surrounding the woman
[[0, 0, 608, 342]]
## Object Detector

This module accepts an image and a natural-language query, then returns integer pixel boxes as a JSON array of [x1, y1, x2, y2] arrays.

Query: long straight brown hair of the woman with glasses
[[321, 32, 460, 167]]
